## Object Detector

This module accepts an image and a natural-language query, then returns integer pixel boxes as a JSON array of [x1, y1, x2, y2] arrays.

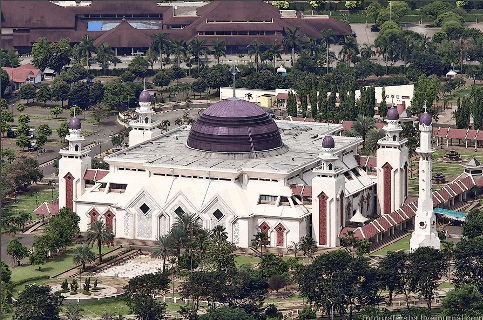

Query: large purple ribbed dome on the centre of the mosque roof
[[187, 100, 282, 152]]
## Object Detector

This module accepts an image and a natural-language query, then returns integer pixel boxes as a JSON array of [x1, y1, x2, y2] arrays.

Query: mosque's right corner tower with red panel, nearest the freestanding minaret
[[377, 107, 409, 214]]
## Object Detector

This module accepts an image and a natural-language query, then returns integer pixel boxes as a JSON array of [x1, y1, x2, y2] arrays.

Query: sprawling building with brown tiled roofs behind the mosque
[[1, 1, 352, 53]]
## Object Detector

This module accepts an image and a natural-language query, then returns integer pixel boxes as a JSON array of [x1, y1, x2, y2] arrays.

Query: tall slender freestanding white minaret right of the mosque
[[409, 112, 440, 251]]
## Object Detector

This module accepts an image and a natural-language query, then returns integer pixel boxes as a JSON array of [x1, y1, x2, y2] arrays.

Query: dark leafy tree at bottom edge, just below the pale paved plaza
[[124, 272, 170, 320]]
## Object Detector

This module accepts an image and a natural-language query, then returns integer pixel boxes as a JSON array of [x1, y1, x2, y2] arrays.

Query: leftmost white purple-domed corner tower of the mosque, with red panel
[[59, 115, 91, 211]]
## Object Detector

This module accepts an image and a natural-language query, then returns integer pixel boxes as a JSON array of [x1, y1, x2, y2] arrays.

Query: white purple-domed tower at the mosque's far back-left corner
[[129, 84, 161, 147]]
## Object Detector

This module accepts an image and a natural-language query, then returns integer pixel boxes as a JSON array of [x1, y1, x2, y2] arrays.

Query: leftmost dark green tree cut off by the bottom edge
[[13, 284, 64, 320]]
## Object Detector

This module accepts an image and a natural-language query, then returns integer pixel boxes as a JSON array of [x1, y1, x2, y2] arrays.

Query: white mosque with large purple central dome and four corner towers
[[55, 90, 438, 249]]
